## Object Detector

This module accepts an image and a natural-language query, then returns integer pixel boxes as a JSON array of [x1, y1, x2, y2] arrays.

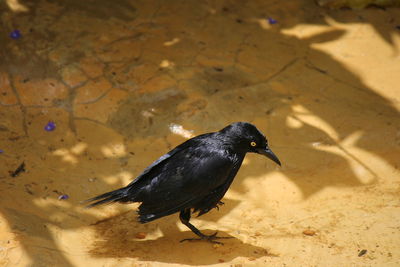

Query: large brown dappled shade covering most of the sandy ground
[[0, 1, 400, 266]]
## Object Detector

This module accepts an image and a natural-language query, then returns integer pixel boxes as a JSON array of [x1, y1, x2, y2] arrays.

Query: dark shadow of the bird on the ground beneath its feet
[[89, 206, 275, 265]]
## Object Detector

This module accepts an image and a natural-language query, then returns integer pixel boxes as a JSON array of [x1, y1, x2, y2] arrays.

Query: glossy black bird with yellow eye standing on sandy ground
[[86, 122, 281, 243]]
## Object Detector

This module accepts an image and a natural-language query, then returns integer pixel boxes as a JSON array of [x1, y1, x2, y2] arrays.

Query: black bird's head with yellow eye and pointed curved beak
[[220, 122, 281, 166]]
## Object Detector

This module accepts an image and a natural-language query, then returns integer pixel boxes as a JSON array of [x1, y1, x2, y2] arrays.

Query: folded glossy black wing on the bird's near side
[[135, 139, 239, 222]]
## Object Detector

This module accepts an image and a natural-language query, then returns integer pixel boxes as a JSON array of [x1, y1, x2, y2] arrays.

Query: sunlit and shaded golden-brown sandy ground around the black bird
[[0, 0, 400, 267]]
